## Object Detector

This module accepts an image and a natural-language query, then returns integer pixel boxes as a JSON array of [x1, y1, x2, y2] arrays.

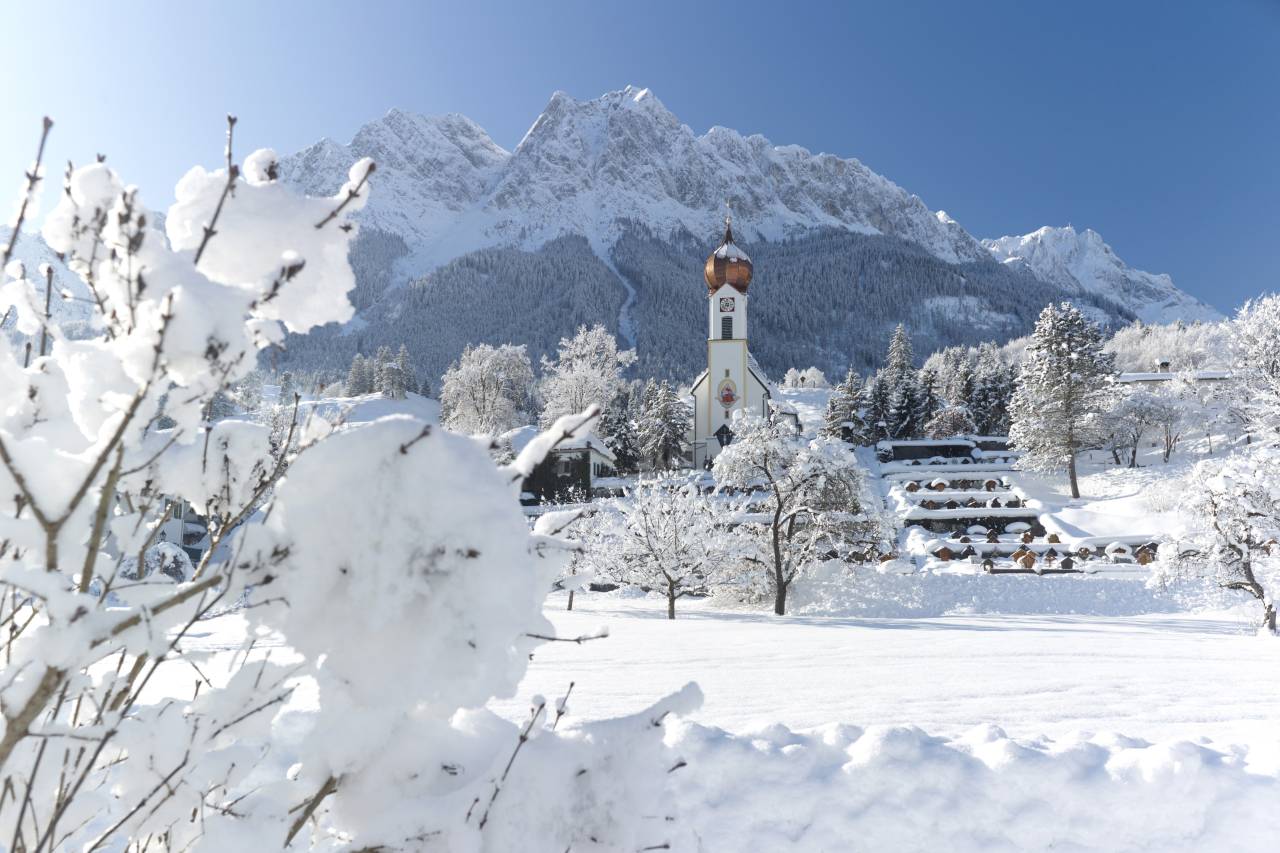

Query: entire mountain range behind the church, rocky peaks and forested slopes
[[5, 87, 1217, 379]]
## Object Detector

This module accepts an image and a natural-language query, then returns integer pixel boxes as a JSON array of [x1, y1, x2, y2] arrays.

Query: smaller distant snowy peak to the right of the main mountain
[[982, 225, 1222, 323]]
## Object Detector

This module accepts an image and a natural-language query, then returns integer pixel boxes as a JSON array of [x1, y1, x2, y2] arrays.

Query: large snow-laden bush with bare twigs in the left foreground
[[0, 119, 698, 850]]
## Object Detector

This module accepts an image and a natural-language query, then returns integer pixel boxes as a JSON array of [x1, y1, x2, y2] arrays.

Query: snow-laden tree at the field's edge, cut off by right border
[[1152, 444, 1280, 634]]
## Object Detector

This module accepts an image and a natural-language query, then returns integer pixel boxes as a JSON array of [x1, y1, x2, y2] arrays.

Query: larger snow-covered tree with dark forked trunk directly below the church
[[713, 416, 883, 616]]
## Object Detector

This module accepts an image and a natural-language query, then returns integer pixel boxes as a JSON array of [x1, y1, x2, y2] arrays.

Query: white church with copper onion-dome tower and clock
[[691, 216, 772, 467]]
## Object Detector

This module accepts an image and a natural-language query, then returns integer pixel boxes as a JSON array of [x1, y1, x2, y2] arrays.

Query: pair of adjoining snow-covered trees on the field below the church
[[575, 418, 887, 619]]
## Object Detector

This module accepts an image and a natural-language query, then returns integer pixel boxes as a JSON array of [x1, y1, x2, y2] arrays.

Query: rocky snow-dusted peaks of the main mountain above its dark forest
[[282, 87, 983, 265]]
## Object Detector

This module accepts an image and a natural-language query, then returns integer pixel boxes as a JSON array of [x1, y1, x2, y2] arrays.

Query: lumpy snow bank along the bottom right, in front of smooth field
[[668, 724, 1280, 853]]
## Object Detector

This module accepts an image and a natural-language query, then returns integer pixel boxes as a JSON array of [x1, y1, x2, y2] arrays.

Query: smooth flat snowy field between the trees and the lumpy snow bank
[[503, 589, 1280, 749]]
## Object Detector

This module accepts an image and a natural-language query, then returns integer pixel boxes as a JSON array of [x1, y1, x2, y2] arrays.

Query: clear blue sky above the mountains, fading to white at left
[[0, 0, 1280, 311]]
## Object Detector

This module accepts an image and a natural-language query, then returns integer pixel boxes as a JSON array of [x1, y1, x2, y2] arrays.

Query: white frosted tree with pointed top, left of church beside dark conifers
[[539, 325, 636, 427]]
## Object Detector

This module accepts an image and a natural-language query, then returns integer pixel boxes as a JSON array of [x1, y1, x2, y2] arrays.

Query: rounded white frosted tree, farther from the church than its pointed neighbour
[[440, 343, 534, 435]]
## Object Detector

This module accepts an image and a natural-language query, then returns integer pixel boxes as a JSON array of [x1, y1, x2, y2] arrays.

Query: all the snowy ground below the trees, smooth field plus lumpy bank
[[167, 591, 1280, 853]]
